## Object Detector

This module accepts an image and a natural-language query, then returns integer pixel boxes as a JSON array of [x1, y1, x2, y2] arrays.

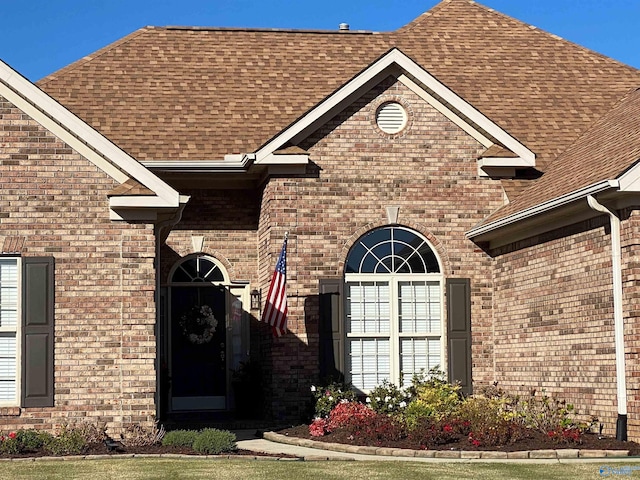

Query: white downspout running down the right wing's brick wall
[[587, 195, 627, 441]]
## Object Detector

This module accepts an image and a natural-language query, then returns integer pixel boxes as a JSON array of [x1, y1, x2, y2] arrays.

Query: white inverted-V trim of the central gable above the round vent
[[255, 48, 535, 167]]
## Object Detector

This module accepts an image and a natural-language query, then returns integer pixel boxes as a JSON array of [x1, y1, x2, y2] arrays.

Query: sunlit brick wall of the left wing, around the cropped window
[[0, 98, 156, 432]]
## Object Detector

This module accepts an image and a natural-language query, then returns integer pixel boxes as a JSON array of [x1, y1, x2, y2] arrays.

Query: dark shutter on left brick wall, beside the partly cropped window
[[22, 257, 54, 407]]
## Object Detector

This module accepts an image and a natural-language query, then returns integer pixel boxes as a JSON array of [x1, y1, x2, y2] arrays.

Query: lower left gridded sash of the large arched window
[[349, 338, 391, 390]]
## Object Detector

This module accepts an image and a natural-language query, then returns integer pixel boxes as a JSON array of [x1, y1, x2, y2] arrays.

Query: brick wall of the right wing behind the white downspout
[[493, 214, 640, 439]]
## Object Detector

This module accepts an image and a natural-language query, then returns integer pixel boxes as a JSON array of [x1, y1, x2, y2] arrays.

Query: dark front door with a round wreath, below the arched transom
[[169, 285, 227, 411]]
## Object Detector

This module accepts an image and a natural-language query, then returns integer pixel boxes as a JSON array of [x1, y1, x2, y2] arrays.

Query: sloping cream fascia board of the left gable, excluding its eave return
[[0, 61, 179, 206]]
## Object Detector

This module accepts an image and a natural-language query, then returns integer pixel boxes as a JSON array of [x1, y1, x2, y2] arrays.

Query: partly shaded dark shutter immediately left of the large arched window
[[318, 278, 344, 381]]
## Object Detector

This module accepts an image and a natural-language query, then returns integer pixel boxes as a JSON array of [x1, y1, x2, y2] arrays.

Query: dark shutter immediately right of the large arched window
[[447, 278, 472, 395]]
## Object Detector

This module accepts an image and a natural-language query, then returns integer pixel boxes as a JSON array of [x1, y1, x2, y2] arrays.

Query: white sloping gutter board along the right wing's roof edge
[[465, 180, 619, 239]]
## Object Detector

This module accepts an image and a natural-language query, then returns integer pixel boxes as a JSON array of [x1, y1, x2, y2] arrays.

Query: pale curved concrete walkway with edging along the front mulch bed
[[234, 430, 640, 465]]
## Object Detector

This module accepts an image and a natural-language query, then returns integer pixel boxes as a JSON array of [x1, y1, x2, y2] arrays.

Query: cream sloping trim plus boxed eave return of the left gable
[[0, 61, 188, 221]]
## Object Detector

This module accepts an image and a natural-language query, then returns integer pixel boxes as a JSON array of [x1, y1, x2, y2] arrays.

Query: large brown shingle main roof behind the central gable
[[39, 0, 640, 176]]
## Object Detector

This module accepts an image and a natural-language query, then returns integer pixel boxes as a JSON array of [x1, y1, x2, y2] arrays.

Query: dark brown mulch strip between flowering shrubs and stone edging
[[277, 425, 640, 456]]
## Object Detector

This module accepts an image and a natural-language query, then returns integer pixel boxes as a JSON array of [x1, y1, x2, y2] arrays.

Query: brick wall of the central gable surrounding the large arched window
[[259, 81, 503, 418]]
